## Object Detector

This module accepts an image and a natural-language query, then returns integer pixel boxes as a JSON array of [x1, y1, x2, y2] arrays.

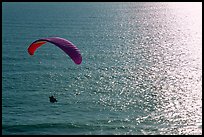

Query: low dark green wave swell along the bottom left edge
[[2, 123, 117, 134]]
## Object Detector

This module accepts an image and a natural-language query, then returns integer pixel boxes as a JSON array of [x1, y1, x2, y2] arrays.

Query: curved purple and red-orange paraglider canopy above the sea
[[28, 37, 82, 64]]
